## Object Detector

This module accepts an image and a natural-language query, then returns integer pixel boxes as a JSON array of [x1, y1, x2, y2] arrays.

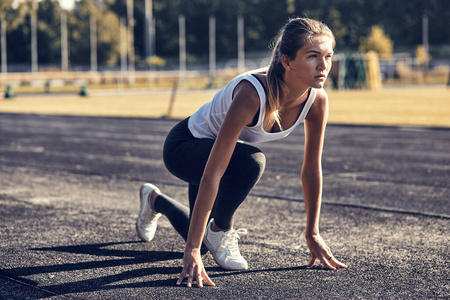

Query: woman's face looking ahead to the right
[[286, 35, 334, 88]]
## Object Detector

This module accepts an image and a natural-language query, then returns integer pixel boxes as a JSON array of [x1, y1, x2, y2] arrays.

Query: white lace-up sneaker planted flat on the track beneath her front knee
[[203, 219, 248, 270]]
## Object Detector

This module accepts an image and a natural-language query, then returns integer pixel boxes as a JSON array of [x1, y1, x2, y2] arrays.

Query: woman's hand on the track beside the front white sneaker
[[177, 246, 215, 288]]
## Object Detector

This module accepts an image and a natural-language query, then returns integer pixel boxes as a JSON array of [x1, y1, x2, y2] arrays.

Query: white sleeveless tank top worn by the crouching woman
[[188, 72, 317, 143]]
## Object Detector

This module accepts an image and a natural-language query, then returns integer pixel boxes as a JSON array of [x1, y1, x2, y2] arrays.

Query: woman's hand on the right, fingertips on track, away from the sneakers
[[306, 234, 347, 270]]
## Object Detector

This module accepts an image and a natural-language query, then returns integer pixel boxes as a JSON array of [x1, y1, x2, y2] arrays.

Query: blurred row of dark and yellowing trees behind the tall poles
[[0, 0, 450, 65]]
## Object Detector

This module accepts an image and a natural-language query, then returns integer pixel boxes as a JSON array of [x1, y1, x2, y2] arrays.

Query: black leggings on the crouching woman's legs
[[155, 118, 266, 240]]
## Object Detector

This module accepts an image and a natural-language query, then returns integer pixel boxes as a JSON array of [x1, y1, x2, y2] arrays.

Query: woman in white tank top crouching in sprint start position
[[136, 18, 346, 287]]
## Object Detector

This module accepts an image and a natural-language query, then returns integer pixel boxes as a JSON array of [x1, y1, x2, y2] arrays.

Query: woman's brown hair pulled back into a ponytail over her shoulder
[[265, 18, 335, 129]]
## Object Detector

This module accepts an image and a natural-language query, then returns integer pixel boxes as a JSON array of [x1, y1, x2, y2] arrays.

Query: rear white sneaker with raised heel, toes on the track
[[136, 183, 162, 242]]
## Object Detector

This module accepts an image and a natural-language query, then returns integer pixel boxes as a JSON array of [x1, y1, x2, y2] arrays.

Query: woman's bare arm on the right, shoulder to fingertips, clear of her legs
[[301, 89, 347, 270]]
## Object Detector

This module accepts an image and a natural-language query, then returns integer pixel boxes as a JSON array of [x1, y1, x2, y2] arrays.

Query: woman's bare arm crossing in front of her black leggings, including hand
[[177, 81, 260, 287]]
